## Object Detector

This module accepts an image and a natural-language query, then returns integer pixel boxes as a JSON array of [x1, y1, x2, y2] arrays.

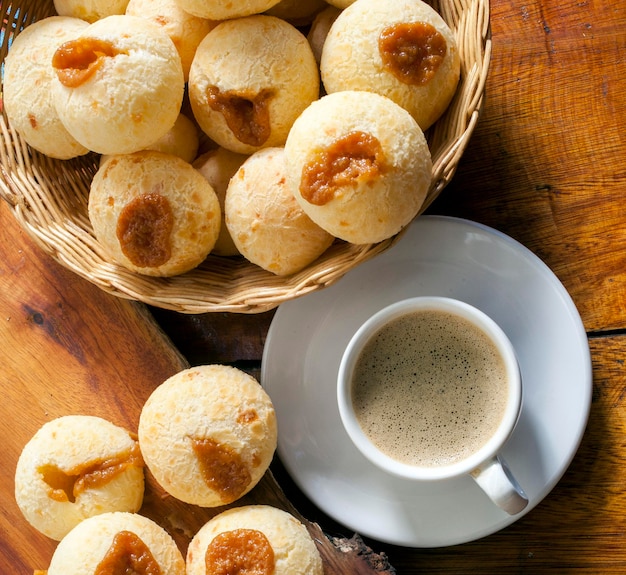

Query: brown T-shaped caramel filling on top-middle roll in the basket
[[207, 86, 273, 146]]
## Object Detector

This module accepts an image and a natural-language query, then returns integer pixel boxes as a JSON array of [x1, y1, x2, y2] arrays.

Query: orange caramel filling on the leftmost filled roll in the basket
[[52, 38, 126, 88]]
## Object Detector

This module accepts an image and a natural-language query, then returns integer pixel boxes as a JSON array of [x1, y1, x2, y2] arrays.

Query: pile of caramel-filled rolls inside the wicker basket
[[4, 0, 460, 277]]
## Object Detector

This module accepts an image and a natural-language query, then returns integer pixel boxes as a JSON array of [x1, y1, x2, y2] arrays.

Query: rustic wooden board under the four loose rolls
[[0, 202, 393, 575]]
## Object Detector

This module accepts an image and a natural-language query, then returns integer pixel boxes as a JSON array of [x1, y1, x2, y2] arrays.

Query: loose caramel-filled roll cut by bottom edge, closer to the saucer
[[186, 505, 324, 575]]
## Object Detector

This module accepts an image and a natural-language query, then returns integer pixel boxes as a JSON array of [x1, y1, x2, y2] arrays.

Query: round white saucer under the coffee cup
[[261, 216, 592, 547]]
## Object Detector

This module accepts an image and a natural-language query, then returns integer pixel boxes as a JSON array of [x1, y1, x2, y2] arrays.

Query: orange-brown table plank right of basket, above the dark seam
[[430, 0, 626, 331]]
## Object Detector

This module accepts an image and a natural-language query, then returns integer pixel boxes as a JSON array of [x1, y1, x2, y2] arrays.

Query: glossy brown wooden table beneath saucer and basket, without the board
[[154, 0, 626, 575]]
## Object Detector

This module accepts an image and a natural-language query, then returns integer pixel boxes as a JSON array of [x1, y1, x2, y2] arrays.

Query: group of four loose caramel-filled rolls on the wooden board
[[15, 365, 323, 575]]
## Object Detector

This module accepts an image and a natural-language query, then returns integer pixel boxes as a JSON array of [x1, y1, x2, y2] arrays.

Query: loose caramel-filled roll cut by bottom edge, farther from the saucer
[[47, 513, 185, 575]]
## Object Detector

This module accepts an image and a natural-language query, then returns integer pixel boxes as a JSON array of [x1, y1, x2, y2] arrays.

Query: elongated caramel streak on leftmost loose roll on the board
[[38, 442, 143, 503]]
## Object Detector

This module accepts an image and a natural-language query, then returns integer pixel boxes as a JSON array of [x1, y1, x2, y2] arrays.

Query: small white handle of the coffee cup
[[470, 455, 528, 515]]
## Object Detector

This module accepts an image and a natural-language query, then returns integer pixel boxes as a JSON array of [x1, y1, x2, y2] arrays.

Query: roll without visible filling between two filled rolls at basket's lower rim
[[224, 148, 334, 276]]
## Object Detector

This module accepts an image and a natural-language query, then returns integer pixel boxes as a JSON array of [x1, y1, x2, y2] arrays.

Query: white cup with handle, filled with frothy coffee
[[337, 296, 528, 515]]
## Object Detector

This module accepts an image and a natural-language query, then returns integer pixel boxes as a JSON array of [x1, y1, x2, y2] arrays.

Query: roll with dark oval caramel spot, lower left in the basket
[[88, 150, 221, 276]]
